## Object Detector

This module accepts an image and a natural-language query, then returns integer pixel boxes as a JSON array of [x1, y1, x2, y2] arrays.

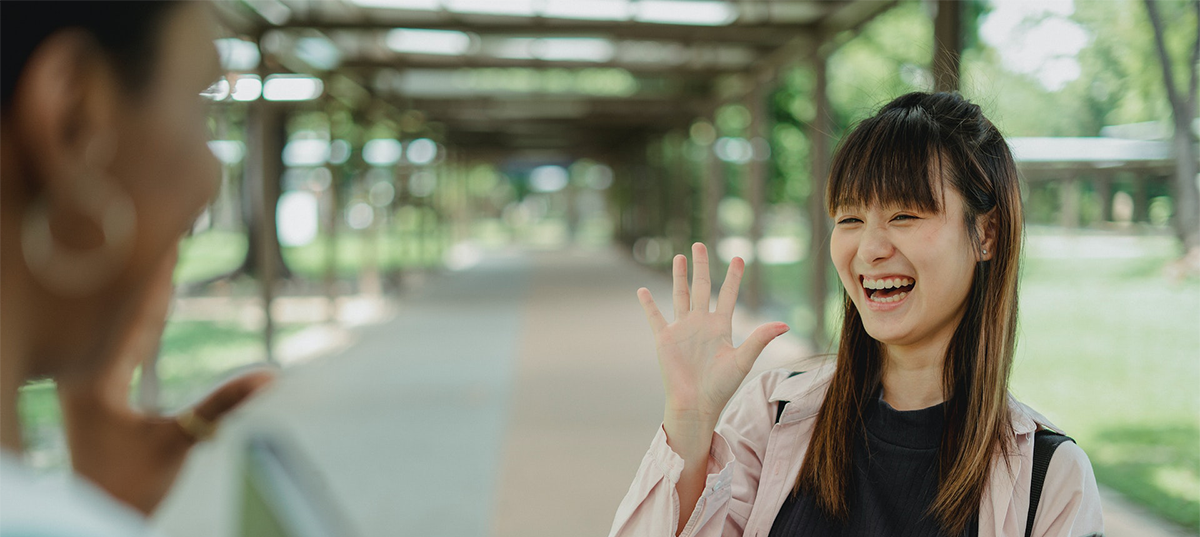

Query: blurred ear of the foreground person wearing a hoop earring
[[10, 30, 118, 210]]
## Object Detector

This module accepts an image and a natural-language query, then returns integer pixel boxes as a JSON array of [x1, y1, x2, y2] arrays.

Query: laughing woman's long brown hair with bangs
[[796, 92, 1024, 535]]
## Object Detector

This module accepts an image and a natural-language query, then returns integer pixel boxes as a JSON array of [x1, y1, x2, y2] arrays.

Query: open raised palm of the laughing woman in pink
[[637, 242, 788, 423]]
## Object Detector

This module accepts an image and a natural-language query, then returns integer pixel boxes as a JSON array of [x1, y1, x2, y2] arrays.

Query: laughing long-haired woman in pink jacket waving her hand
[[612, 92, 1103, 537]]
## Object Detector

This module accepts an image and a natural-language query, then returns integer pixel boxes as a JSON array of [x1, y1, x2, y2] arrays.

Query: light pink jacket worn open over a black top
[[608, 366, 1104, 537]]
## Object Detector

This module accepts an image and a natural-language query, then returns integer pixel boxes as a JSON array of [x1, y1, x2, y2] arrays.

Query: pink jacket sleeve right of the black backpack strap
[[1032, 442, 1104, 537]]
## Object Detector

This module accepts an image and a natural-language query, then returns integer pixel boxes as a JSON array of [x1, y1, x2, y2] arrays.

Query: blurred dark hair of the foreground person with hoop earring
[[0, 0, 180, 108]]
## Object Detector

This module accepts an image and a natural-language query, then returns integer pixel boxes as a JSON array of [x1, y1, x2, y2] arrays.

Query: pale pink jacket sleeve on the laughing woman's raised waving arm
[[608, 370, 787, 537]]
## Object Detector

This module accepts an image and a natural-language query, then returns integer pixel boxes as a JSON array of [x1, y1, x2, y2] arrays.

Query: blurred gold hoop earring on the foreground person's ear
[[20, 176, 137, 297]]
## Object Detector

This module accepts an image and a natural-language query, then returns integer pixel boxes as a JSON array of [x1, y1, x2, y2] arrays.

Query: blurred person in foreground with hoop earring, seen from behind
[[0, 1, 271, 536]]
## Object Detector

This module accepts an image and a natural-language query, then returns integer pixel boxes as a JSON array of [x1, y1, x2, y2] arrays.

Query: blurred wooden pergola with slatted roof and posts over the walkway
[[201, 0, 962, 359]]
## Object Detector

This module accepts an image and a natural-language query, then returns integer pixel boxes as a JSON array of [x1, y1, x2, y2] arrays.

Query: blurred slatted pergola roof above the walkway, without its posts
[[221, 0, 894, 151]]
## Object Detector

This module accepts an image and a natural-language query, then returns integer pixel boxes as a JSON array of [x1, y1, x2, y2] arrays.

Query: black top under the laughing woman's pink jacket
[[770, 398, 979, 537]]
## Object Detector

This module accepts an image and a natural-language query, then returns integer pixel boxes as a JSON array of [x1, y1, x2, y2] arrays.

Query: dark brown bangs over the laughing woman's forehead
[[826, 108, 944, 216]]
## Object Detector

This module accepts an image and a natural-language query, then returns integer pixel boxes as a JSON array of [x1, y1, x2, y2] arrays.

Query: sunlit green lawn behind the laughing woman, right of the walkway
[[766, 228, 1200, 531]]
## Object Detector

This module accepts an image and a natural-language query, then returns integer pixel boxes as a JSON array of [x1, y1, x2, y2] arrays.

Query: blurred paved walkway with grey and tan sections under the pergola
[[157, 246, 1195, 537]]
